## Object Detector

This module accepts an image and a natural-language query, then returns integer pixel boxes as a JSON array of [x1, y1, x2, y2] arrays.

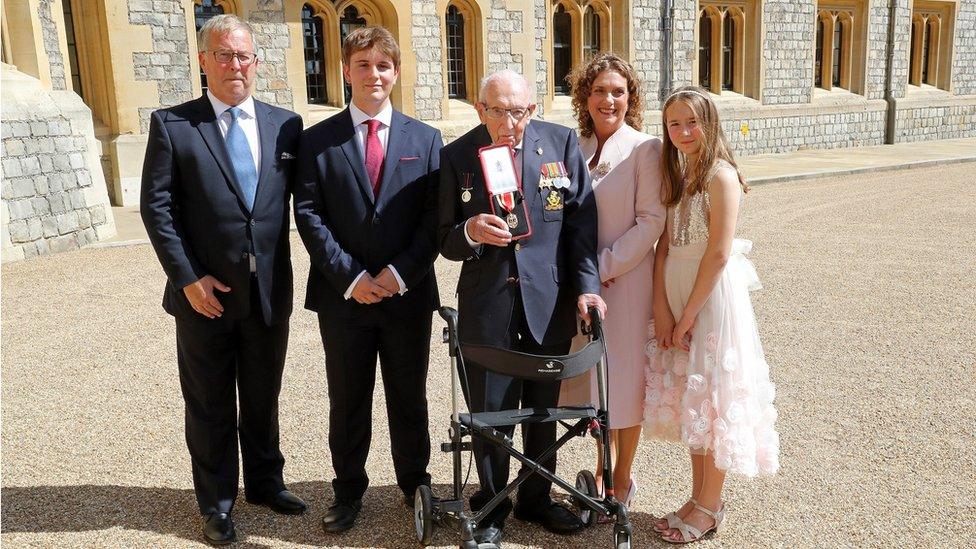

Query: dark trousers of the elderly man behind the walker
[[460, 294, 571, 525]]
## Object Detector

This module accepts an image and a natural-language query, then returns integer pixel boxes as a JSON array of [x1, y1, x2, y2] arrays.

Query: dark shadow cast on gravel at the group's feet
[[0, 482, 652, 549]]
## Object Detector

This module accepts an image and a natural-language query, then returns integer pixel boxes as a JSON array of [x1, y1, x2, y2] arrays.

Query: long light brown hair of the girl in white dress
[[661, 86, 749, 207]]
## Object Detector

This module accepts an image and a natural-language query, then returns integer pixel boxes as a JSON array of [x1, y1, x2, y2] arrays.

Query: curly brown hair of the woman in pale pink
[[566, 53, 644, 137]]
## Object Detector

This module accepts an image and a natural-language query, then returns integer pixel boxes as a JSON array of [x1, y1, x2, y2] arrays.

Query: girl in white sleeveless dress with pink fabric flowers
[[644, 86, 779, 543]]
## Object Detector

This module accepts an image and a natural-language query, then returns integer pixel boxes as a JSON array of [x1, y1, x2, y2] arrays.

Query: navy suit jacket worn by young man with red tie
[[295, 109, 443, 316]]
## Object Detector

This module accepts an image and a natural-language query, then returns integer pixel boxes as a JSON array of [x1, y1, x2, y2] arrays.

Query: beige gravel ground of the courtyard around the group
[[0, 164, 976, 548]]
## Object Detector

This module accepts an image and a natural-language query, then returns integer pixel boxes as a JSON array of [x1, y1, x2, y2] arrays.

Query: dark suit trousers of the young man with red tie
[[319, 310, 431, 499]]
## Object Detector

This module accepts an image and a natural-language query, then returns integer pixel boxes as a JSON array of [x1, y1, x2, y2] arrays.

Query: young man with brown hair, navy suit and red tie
[[295, 26, 441, 534]]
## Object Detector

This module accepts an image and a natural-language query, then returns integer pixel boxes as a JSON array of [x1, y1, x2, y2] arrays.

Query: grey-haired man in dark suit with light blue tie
[[141, 15, 305, 544]]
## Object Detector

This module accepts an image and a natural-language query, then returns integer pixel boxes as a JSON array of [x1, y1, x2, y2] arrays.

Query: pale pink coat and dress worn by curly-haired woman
[[559, 125, 666, 429]]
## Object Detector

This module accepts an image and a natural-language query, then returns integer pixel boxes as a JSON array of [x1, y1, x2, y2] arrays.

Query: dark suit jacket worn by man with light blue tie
[[140, 95, 302, 325]]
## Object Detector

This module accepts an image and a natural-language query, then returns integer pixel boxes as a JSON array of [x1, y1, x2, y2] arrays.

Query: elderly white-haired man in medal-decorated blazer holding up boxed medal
[[438, 70, 606, 543]]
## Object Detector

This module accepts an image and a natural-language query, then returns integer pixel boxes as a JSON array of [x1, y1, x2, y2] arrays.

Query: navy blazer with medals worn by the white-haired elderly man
[[438, 120, 600, 345]]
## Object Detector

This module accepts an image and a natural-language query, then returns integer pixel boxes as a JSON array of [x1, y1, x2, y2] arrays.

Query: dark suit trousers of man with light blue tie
[[176, 280, 288, 514]]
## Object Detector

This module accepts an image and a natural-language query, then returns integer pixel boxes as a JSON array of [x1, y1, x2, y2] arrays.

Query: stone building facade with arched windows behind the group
[[3, 0, 976, 218]]
